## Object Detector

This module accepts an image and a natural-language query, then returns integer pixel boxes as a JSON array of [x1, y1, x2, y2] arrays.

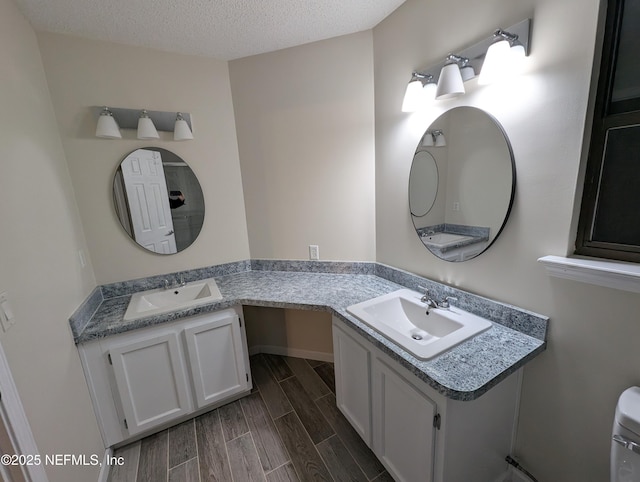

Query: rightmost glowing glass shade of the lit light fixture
[[478, 29, 525, 85]]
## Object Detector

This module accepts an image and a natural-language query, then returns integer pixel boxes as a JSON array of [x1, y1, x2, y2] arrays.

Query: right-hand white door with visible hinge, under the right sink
[[372, 358, 436, 482]]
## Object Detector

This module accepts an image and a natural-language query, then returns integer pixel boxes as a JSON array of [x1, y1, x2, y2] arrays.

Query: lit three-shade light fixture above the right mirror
[[402, 19, 531, 112]]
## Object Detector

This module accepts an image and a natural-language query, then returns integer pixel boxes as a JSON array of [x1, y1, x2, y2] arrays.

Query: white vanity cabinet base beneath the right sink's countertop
[[333, 317, 520, 482]]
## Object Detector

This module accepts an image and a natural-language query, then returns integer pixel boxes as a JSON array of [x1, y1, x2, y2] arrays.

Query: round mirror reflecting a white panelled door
[[113, 147, 204, 254]]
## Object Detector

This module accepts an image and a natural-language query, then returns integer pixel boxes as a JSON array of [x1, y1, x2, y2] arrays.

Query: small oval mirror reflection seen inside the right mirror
[[409, 151, 438, 217]]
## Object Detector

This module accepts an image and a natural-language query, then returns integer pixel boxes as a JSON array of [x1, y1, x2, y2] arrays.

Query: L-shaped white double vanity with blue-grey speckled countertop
[[71, 260, 548, 482]]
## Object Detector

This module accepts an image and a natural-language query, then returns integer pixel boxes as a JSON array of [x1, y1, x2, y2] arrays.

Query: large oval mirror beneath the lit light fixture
[[409, 107, 516, 261]]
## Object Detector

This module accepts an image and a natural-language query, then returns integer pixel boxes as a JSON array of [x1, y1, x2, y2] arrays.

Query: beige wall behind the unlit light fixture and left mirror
[[38, 33, 249, 284]]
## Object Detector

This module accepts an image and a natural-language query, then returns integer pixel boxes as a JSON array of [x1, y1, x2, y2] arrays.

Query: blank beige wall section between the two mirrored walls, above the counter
[[229, 31, 375, 261]]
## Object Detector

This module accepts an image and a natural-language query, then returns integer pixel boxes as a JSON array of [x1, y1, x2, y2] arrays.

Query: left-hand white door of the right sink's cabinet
[[333, 323, 371, 446]]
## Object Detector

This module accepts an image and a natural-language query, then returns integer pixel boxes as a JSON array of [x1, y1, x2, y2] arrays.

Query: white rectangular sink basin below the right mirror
[[347, 289, 491, 360]]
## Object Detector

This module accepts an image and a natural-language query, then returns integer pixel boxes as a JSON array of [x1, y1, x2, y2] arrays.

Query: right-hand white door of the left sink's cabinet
[[184, 312, 251, 408]]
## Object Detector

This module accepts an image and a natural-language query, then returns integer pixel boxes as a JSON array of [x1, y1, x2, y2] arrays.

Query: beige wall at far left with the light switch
[[0, 0, 104, 482]]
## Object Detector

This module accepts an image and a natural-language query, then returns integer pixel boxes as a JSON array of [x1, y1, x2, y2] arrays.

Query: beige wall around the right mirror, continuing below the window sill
[[374, 0, 640, 482]]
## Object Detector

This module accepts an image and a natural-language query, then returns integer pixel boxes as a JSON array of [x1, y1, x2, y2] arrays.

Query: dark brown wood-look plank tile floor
[[109, 354, 393, 482]]
